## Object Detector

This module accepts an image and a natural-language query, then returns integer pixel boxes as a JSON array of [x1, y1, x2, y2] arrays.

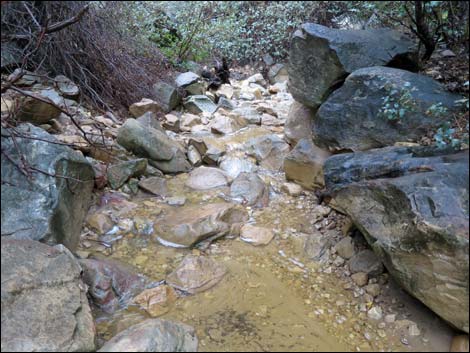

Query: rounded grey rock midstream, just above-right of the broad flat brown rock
[[230, 173, 269, 208]]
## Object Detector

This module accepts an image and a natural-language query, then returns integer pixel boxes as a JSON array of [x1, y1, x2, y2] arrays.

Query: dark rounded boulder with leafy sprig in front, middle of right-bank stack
[[313, 66, 462, 151]]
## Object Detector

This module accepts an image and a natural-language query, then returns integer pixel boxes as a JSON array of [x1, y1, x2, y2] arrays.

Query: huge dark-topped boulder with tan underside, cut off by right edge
[[324, 147, 469, 333]]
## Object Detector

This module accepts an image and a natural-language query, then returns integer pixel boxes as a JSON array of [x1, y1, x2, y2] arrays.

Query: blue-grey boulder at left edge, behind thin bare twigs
[[1, 124, 94, 251]]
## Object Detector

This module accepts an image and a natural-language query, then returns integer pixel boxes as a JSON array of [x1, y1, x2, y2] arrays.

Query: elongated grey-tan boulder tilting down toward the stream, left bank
[[117, 119, 191, 173]]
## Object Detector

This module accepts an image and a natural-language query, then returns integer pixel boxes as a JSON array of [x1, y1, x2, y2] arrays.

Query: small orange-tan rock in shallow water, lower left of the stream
[[132, 285, 177, 317]]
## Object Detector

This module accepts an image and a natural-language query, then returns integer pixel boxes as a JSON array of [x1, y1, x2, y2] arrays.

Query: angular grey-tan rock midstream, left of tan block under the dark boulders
[[245, 135, 289, 171]]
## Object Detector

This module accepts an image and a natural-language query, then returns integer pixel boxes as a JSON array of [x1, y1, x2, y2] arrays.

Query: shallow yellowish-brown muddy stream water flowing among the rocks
[[84, 106, 451, 352]]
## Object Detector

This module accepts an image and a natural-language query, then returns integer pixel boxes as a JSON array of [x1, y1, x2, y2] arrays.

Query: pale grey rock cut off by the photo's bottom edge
[[98, 319, 198, 352]]
